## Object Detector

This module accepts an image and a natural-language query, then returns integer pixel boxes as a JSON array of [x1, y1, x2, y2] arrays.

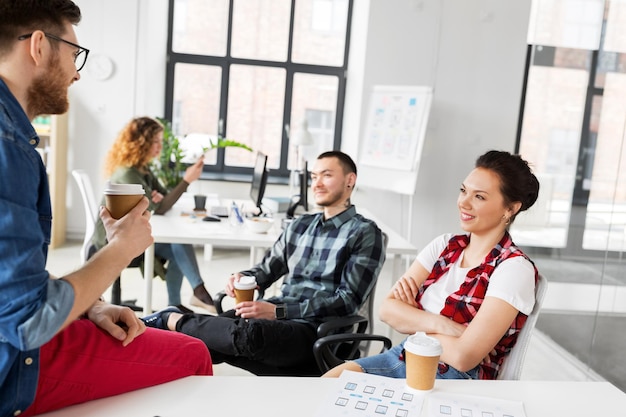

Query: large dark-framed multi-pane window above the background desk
[[165, 0, 352, 176]]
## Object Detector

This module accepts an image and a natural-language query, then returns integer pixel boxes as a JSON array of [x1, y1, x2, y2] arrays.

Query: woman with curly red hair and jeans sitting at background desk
[[92, 117, 216, 314]]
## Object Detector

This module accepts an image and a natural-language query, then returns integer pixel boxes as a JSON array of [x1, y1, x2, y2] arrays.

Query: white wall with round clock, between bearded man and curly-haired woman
[[67, 0, 168, 239]]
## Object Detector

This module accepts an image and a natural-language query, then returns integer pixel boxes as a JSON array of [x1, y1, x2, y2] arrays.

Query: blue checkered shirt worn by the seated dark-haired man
[[242, 206, 385, 323]]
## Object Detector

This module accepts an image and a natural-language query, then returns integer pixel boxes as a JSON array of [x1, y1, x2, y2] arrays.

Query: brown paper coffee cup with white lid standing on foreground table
[[404, 332, 442, 391]]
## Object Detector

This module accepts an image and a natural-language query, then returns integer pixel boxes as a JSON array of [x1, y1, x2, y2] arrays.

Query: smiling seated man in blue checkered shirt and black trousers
[[143, 151, 385, 369]]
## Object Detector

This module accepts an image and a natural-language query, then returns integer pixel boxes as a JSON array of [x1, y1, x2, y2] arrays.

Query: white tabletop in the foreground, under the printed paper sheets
[[37, 376, 626, 417]]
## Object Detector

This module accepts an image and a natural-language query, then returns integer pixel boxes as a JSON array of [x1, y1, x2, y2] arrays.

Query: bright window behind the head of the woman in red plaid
[[514, 0, 626, 255]]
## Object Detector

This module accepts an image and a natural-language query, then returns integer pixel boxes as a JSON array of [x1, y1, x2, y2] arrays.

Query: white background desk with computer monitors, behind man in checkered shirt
[[144, 193, 417, 315]]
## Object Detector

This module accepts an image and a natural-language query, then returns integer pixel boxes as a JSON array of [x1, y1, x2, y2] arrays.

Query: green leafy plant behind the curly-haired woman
[[154, 117, 252, 189]]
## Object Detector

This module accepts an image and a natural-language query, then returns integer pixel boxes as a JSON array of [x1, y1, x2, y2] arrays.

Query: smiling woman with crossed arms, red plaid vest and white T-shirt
[[324, 151, 539, 379]]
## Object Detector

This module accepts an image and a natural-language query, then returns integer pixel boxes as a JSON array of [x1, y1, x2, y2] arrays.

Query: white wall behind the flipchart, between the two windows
[[343, 0, 530, 247]]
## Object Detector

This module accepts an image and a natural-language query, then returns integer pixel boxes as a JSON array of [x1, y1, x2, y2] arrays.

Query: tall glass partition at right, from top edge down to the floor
[[513, 0, 626, 390]]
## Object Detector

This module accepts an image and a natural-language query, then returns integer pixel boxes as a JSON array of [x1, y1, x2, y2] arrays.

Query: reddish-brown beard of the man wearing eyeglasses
[[28, 54, 69, 116]]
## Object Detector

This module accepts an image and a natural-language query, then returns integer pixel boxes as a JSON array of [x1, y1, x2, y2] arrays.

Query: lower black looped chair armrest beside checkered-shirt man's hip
[[313, 333, 392, 373]]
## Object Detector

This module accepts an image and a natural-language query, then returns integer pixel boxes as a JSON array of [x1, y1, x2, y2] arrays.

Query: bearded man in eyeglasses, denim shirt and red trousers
[[0, 0, 212, 417]]
